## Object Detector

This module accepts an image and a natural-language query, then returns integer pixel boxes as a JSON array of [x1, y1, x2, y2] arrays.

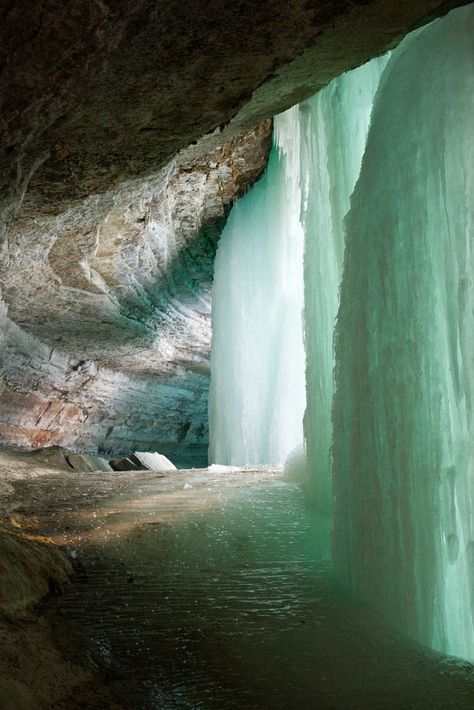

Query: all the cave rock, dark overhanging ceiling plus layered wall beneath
[[0, 0, 463, 466]]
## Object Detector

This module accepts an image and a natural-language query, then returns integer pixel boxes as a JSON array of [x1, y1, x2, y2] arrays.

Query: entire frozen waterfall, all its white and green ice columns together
[[210, 5, 474, 660]]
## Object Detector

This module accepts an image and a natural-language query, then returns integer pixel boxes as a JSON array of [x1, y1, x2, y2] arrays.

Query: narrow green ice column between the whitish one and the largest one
[[298, 56, 388, 511]]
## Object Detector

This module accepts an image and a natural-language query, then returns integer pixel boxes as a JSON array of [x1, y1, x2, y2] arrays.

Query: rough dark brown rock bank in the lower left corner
[[0, 452, 119, 710]]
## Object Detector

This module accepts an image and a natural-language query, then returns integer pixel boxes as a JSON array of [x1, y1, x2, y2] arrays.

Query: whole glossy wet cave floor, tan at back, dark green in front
[[0, 457, 474, 710]]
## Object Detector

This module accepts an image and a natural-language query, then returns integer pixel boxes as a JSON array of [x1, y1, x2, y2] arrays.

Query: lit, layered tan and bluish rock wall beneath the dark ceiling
[[0, 126, 271, 464]]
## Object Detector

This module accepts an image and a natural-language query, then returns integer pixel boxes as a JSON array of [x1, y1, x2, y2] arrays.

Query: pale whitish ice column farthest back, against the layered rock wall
[[209, 109, 305, 465]]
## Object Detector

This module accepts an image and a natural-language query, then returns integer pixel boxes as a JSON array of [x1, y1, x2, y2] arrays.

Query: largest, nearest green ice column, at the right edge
[[332, 5, 474, 659]]
